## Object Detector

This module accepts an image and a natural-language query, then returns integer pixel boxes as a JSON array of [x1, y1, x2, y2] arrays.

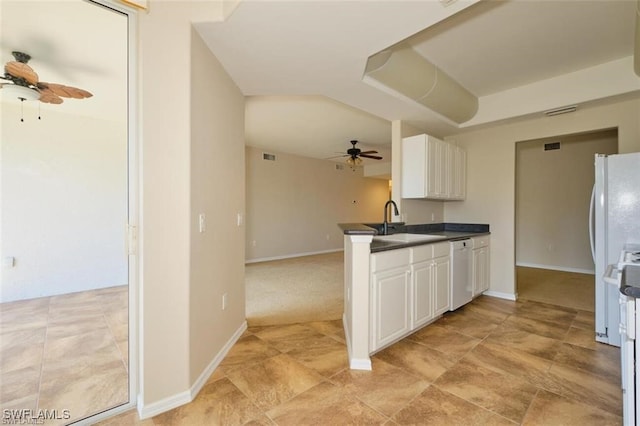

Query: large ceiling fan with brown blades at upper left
[[0, 51, 93, 104]]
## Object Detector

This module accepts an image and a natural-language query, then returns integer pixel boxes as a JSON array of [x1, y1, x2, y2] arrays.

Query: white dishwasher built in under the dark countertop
[[449, 238, 473, 311]]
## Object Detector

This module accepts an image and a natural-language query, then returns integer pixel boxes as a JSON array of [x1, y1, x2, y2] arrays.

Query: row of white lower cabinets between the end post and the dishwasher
[[370, 243, 450, 351]]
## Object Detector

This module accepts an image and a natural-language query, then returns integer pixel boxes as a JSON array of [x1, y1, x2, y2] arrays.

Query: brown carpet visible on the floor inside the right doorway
[[516, 266, 595, 312]]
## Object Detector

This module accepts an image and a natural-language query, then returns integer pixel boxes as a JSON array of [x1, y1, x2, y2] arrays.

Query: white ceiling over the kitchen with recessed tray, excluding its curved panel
[[196, 0, 640, 158]]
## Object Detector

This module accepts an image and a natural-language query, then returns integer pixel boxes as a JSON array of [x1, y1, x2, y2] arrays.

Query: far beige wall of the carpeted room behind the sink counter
[[246, 147, 389, 262]]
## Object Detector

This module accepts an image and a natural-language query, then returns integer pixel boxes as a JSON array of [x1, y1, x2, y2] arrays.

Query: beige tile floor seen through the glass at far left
[[0, 286, 129, 425]]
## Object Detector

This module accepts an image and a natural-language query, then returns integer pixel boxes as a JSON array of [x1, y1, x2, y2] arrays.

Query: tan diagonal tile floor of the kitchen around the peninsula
[[102, 296, 622, 426]]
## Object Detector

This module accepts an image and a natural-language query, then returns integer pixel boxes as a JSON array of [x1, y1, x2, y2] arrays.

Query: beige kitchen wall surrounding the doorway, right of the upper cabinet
[[444, 99, 640, 297]]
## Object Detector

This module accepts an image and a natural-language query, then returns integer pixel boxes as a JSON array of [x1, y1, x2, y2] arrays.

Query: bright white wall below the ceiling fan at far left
[[0, 108, 128, 303]]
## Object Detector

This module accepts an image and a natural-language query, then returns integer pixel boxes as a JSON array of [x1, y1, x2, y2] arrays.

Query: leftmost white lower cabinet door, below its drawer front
[[371, 268, 411, 350]]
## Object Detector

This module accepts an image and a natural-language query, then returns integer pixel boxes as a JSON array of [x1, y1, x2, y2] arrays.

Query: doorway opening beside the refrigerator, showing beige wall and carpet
[[515, 129, 618, 312]]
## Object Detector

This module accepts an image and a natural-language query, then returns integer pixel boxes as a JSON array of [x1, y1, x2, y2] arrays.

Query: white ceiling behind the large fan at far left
[[0, 0, 128, 122]]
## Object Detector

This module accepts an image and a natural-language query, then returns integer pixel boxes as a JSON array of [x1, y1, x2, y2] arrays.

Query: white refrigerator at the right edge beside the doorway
[[589, 152, 640, 346]]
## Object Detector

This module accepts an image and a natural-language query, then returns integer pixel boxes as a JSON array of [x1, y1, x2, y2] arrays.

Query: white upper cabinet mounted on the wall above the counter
[[402, 135, 467, 200]]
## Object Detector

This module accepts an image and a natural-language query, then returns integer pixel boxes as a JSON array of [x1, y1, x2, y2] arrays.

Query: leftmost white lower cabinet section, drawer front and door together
[[370, 249, 411, 351]]
